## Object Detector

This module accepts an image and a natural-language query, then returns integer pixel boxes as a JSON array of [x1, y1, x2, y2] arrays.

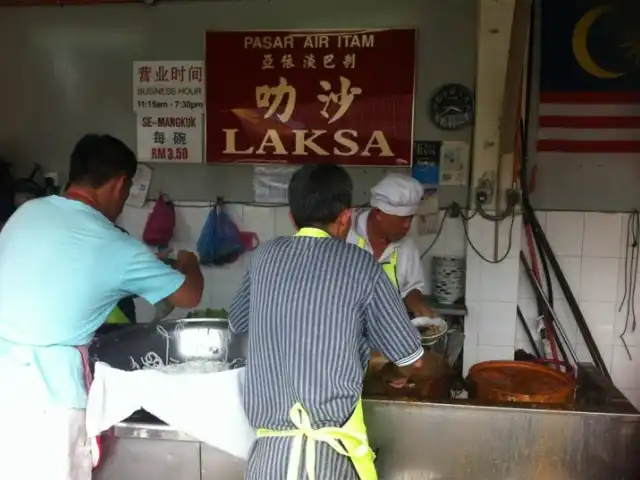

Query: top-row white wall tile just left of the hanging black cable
[[582, 212, 622, 257]]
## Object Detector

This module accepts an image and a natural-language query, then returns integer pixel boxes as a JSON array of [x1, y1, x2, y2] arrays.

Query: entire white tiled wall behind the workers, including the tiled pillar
[[119, 203, 640, 407]]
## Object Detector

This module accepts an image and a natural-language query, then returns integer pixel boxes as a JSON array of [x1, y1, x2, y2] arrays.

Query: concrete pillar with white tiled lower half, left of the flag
[[464, 0, 529, 373]]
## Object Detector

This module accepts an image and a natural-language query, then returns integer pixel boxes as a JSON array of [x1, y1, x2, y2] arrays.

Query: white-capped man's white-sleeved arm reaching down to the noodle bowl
[[396, 238, 436, 317]]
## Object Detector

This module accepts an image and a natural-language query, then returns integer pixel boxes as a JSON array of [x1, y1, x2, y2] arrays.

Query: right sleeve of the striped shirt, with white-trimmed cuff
[[365, 268, 424, 367]]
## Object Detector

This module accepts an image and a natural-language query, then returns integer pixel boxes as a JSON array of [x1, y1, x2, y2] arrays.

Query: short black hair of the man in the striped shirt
[[288, 165, 353, 228]]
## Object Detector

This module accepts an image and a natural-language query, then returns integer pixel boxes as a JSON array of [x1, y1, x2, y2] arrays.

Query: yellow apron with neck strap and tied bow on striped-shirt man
[[256, 228, 378, 480]]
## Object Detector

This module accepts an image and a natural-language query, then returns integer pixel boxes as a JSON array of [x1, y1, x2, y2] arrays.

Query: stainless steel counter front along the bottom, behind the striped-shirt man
[[95, 400, 640, 480]]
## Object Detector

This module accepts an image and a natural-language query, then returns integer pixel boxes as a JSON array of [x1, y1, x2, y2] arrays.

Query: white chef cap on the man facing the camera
[[371, 173, 423, 217]]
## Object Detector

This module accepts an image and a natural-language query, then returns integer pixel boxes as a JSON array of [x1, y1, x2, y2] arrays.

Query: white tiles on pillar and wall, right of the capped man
[[464, 212, 640, 408]]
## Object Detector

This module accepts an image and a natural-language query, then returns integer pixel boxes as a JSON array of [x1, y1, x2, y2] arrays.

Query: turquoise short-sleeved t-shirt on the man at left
[[0, 196, 184, 408]]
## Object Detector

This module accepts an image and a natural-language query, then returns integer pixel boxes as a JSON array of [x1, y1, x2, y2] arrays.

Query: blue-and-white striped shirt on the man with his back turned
[[229, 237, 423, 429]]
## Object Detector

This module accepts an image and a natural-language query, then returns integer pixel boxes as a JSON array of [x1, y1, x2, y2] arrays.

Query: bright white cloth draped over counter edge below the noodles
[[87, 362, 255, 459]]
